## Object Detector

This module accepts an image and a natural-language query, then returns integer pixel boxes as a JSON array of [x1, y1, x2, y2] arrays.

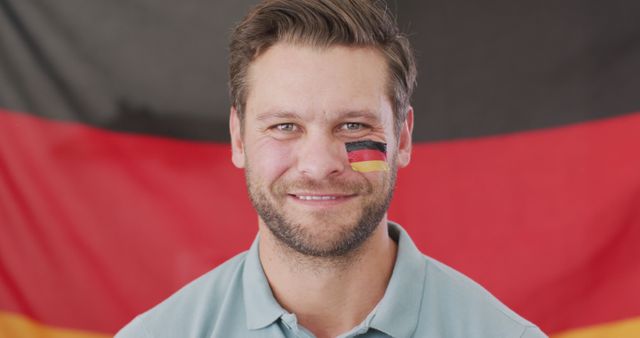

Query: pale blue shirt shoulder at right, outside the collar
[[416, 256, 546, 338]]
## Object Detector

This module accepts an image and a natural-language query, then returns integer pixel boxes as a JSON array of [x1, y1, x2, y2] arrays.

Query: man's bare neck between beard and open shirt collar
[[259, 217, 397, 337]]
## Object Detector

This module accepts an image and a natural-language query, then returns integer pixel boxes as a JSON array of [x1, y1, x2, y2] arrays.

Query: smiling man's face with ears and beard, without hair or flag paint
[[230, 43, 412, 257]]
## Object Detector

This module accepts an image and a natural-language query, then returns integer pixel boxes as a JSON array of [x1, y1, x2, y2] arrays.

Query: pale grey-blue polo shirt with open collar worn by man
[[116, 222, 546, 338]]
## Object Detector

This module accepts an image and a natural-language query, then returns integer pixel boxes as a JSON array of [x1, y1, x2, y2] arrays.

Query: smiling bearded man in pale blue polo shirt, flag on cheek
[[118, 0, 544, 338]]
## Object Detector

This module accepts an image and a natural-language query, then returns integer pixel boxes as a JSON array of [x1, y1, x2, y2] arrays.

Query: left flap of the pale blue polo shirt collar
[[242, 237, 286, 330]]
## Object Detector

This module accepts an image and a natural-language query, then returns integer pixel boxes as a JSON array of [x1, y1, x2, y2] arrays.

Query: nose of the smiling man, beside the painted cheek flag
[[296, 133, 348, 180]]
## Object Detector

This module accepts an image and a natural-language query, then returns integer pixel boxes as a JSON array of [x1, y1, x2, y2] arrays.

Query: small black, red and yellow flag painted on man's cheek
[[345, 140, 389, 173]]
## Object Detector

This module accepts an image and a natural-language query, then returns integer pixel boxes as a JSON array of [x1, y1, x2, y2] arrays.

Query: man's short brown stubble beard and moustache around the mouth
[[245, 161, 397, 260]]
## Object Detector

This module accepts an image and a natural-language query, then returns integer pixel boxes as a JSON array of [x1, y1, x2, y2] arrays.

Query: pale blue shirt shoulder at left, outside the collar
[[116, 252, 247, 338]]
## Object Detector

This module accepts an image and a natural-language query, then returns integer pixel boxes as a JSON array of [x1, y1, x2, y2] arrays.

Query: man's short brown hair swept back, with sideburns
[[229, 0, 417, 131]]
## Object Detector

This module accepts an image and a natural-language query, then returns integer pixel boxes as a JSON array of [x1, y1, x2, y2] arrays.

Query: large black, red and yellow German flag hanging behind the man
[[0, 0, 640, 338]]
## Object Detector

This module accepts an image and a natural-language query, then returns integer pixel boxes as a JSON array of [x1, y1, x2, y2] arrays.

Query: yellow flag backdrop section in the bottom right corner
[[551, 317, 640, 338]]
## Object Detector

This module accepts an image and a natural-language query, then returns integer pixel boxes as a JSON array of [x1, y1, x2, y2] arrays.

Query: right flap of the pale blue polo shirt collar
[[370, 222, 426, 338]]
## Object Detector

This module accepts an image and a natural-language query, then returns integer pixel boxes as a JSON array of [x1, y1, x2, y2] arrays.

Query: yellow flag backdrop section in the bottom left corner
[[0, 311, 113, 338]]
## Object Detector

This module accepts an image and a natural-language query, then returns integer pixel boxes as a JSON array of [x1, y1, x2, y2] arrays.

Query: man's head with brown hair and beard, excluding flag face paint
[[230, 0, 415, 257]]
